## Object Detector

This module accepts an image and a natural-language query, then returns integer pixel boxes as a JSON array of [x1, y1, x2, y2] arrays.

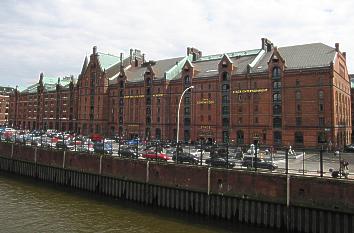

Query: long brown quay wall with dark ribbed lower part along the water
[[0, 143, 354, 233]]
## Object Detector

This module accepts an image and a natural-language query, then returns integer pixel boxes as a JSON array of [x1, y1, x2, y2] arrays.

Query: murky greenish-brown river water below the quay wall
[[0, 173, 277, 233]]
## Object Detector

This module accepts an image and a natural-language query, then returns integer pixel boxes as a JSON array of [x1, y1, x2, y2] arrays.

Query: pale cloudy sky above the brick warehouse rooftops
[[0, 0, 354, 87]]
